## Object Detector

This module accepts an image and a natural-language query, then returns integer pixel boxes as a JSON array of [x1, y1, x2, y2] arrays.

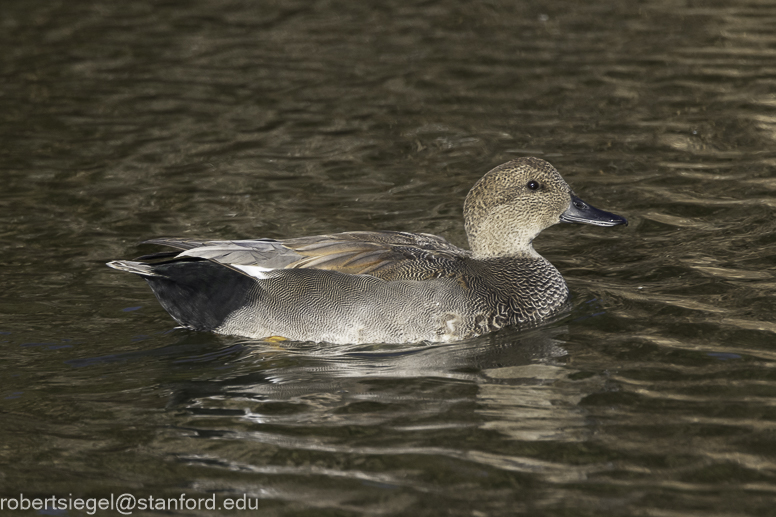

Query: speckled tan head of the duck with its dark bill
[[463, 158, 628, 258]]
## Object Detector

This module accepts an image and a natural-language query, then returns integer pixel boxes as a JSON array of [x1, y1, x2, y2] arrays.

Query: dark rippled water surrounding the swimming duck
[[0, 0, 776, 517]]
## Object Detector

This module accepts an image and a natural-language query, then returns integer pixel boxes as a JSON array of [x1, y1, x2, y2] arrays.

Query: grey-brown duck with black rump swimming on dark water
[[107, 157, 627, 344]]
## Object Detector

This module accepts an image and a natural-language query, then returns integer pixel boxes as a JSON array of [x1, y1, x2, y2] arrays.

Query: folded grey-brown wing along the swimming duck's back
[[141, 232, 470, 279]]
